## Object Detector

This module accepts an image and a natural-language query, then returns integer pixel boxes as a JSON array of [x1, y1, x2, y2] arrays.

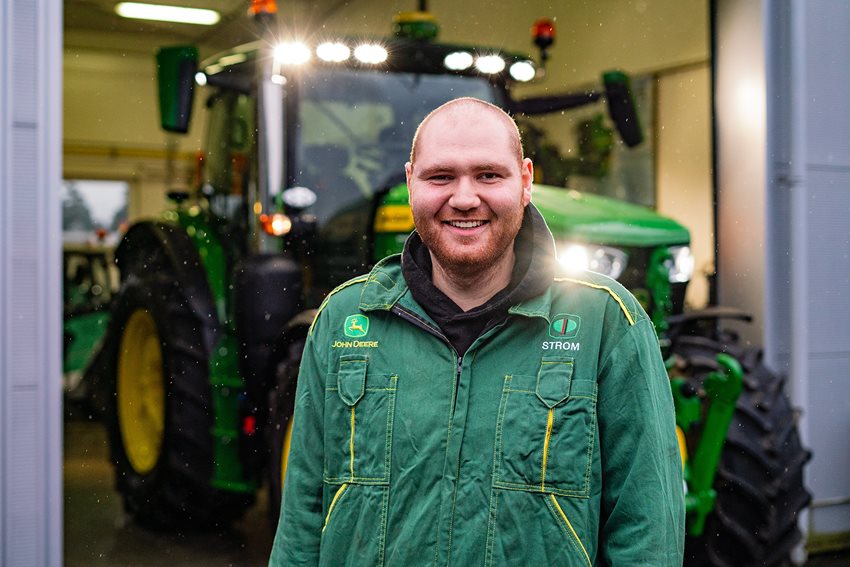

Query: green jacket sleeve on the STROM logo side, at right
[[598, 319, 685, 567]]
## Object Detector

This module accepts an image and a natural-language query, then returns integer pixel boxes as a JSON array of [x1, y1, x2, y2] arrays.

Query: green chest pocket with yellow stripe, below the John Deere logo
[[324, 354, 398, 484]]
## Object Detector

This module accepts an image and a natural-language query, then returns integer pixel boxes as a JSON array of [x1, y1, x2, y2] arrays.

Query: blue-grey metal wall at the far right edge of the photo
[[766, 0, 850, 546]]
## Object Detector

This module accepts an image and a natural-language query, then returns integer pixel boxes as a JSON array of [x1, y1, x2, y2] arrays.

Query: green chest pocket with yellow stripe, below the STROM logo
[[493, 355, 596, 497]]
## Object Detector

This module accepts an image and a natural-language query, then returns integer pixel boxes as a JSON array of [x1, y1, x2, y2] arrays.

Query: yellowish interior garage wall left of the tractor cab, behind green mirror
[[63, 28, 205, 218]]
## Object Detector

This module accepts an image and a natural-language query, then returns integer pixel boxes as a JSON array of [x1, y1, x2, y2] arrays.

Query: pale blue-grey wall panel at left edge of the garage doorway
[[0, 0, 62, 567]]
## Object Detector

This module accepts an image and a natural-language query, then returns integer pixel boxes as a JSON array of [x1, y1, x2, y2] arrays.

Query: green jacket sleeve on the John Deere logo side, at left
[[269, 325, 327, 567]]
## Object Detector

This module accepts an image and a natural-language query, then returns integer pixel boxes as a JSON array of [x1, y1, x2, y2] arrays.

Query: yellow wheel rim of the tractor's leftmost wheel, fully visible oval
[[117, 309, 165, 474]]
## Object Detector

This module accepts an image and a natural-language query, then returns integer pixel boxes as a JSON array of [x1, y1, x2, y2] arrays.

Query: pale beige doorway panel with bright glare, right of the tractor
[[715, 0, 766, 345]]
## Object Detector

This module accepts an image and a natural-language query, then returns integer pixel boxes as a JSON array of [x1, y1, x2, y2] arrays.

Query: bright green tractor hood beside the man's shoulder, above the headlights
[[532, 185, 690, 247]]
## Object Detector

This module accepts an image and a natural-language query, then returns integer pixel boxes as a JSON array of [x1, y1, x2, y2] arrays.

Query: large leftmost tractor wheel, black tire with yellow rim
[[105, 272, 251, 529]]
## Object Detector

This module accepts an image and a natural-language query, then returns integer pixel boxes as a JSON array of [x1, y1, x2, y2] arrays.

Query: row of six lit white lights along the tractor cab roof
[[274, 42, 536, 82]]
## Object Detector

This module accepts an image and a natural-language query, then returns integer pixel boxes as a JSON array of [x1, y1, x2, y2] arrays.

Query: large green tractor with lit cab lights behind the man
[[92, 4, 809, 565]]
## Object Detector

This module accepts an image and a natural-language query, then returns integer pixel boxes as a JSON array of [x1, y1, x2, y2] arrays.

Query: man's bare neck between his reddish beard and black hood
[[431, 247, 516, 311]]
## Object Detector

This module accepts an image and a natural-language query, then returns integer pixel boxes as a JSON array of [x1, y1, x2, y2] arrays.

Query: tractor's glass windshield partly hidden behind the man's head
[[290, 69, 502, 226]]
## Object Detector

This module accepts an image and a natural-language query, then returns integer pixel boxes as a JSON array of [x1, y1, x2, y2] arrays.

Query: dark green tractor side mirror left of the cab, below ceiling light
[[156, 45, 198, 134]]
